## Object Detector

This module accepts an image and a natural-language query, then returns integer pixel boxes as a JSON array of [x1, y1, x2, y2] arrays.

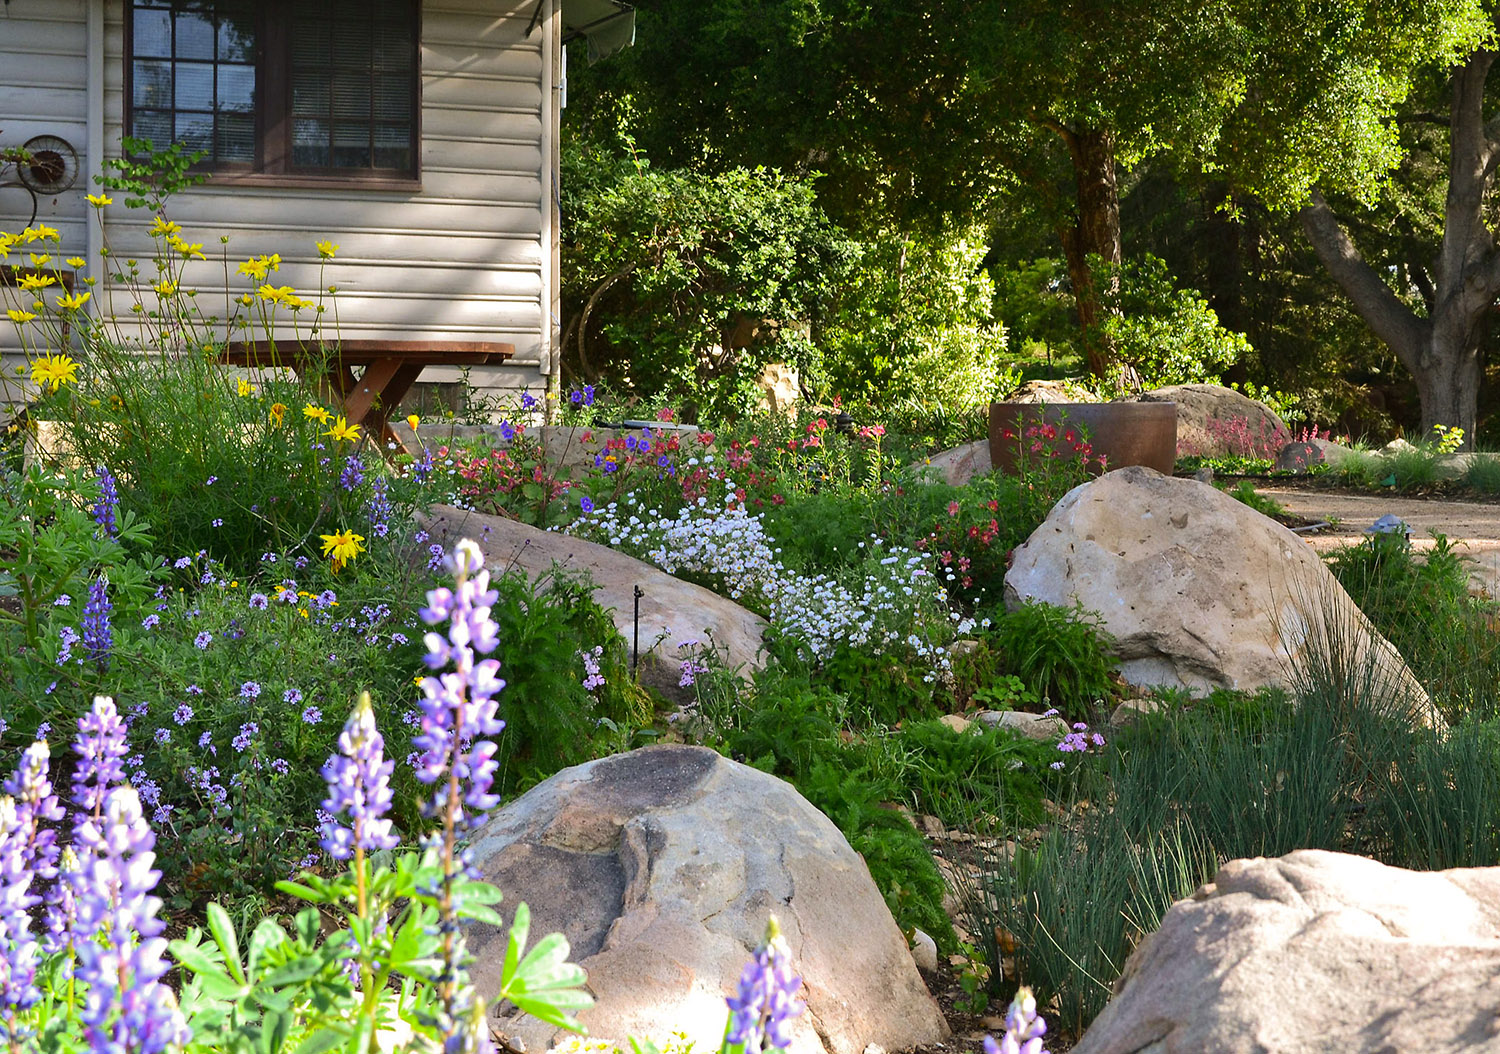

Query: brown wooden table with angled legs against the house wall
[[219, 340, 516, 456]]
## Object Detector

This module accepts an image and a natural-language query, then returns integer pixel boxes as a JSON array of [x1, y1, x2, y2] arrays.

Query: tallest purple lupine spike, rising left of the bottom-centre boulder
[[411, 538, 506, 831]]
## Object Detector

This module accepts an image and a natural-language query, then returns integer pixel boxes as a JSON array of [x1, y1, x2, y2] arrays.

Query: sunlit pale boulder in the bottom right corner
[[1073, 850, 1500, 1054]]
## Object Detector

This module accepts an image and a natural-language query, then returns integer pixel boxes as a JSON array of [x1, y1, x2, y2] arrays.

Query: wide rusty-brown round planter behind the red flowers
[[990, 402, 1178, 475]]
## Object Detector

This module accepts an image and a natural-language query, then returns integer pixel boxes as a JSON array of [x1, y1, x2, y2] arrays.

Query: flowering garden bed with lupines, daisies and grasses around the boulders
[[0, 196, 1500, 1050]]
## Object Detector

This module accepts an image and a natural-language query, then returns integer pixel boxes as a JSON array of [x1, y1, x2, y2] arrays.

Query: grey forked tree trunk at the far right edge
[[1301, 51, 1500, 450]]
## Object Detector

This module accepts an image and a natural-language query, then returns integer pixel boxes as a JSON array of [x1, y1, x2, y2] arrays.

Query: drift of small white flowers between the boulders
[[567, 480, 972, 682]]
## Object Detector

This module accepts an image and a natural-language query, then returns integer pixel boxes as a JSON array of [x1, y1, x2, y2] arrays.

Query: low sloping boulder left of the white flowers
[[423, 505, 765, 690]]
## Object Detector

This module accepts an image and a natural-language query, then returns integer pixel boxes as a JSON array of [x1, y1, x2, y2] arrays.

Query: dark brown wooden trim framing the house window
[[122, 0, 422, 192]]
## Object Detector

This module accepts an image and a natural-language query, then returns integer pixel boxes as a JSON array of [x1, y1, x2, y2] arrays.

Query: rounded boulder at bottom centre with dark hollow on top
[[468, 745, 948, 1054]]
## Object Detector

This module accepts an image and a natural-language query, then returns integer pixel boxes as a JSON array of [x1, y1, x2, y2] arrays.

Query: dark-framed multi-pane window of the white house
[[126, 0, 419, 180]]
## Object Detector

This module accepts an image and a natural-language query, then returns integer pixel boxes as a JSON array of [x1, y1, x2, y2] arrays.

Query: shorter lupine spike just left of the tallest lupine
[[321, 691, 401, 861]]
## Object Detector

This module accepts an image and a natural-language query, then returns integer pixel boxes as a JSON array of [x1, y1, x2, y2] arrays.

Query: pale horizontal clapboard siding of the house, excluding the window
[[0, 0, 548, 404]]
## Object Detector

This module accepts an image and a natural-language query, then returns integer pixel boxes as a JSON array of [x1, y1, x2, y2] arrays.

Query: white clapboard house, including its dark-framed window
[[0, 0, 635, 407]]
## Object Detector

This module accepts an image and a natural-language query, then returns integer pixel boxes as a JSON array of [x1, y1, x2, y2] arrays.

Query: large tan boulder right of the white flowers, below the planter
[[1005, 466, 1433, 720]]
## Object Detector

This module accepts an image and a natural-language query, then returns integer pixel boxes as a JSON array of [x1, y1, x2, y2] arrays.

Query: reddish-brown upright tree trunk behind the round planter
[[1055, 126, 1121, 376]]
